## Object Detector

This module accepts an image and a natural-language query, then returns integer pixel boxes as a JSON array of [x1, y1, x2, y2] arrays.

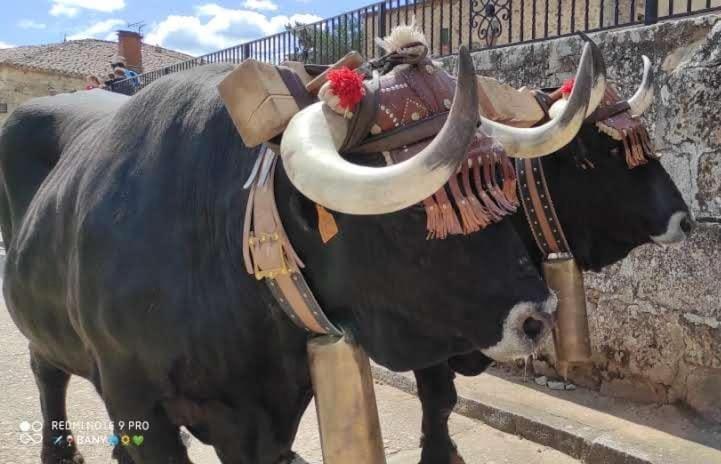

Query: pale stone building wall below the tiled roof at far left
[[0, 64, 85, 125]]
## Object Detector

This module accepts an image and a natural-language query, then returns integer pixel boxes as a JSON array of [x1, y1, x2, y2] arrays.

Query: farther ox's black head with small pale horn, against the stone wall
[[544, 49, 693, 270]]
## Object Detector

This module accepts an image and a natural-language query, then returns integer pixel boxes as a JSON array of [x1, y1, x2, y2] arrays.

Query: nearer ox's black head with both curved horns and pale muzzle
[[272, 47, 594, 369]]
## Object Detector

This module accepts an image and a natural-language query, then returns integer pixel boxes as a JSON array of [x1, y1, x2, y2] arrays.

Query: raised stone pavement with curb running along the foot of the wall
[[373, 365, 721, 464]]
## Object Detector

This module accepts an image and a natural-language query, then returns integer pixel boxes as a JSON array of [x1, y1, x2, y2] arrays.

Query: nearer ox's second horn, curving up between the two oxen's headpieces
[[481, 43, 605, 158]]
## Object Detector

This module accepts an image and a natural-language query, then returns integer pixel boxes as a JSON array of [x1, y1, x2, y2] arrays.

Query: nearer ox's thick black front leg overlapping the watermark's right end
[[101, 369, 192, 464]]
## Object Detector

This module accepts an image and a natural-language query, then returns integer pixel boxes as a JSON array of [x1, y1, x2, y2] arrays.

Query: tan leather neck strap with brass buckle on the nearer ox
[[243, 147, 343, 336]]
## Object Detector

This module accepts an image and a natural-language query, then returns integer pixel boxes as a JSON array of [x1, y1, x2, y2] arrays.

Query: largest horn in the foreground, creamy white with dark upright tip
[[280, 47, 478, 214]]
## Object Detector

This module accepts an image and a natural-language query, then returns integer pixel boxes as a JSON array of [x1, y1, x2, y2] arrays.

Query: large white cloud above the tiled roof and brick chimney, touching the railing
[[145, 3, 322, 55]]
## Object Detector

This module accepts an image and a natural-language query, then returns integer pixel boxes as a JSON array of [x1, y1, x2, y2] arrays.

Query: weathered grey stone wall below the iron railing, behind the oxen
[[438, 15, 721, 422]]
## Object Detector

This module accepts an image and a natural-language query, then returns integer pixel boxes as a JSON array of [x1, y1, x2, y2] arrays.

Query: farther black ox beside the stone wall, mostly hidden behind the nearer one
[[414, 57, 694, 464]]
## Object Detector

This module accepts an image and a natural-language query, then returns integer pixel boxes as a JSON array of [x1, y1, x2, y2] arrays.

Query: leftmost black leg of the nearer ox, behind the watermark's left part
[[30, 348, 85, 464]]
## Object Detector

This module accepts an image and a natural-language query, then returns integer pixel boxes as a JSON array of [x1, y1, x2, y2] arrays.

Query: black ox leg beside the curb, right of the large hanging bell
[[413, 362, 464, 464]]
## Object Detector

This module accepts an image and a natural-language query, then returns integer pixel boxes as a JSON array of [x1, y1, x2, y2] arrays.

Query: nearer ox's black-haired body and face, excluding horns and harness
[[0, 65, 549, 464]]
